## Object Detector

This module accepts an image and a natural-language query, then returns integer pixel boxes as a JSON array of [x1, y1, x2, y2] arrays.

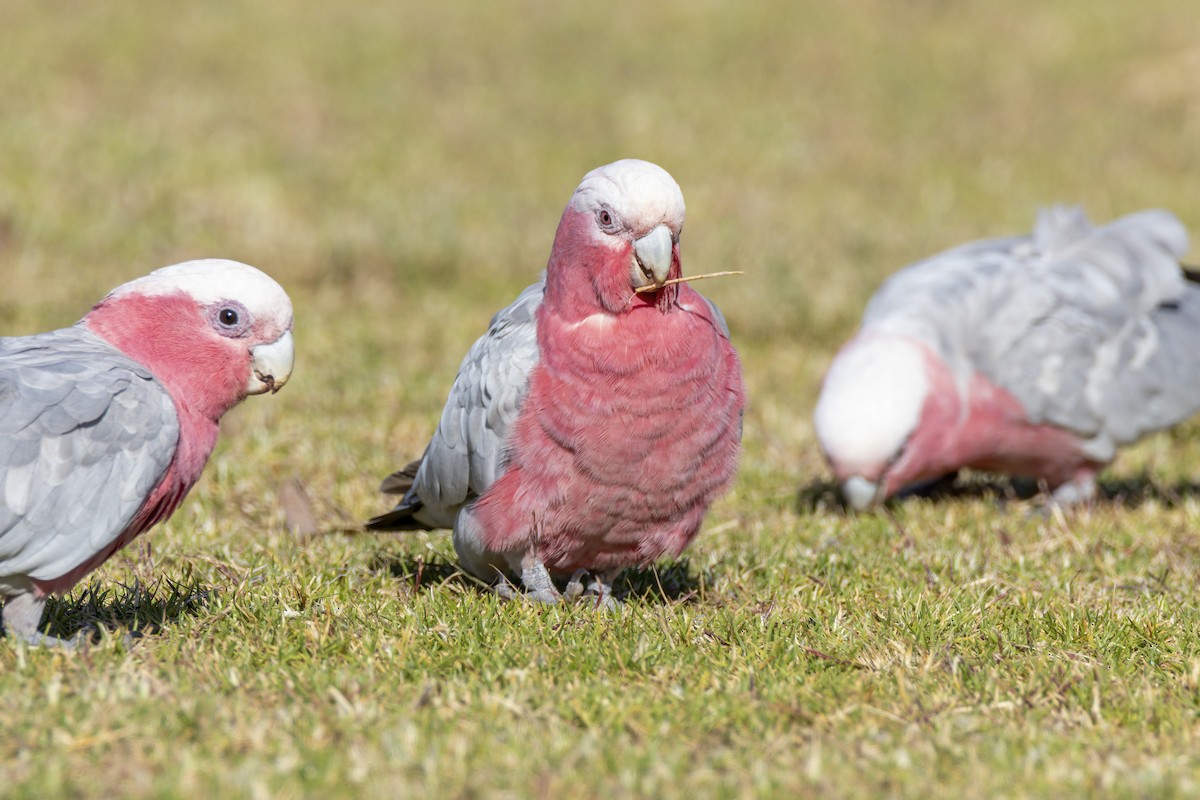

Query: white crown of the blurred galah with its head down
[[814, 337, 929, 480]]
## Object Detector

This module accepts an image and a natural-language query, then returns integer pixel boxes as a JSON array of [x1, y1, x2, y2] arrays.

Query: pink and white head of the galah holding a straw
[[546, 158, 684, 318]]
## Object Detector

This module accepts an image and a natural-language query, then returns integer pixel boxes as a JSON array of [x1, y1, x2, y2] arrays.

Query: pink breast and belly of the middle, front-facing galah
[[475, 291, 745, 572]]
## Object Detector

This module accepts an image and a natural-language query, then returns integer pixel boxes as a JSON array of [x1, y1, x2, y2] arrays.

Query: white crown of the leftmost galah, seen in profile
[[108, 258, 292, 327]]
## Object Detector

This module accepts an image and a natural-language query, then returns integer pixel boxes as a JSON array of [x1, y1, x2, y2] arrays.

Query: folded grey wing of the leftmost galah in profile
[[0, 326, 179, 584]]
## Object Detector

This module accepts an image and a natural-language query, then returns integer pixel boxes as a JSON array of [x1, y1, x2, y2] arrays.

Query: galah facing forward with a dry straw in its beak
[[367, 160, 745, 606]]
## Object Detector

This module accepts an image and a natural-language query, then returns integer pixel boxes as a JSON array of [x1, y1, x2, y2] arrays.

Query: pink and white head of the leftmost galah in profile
[[82, 259, 294, 422]]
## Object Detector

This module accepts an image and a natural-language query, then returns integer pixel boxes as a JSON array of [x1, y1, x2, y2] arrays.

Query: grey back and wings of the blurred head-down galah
[[863, 207, 1200, 462]]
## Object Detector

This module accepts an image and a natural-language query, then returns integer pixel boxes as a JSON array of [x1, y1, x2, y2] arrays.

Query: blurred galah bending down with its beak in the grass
[[815, 207, 1200, 509]]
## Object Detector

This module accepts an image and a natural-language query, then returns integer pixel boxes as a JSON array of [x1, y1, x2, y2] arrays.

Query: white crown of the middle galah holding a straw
[[570, 158, 684, 234]]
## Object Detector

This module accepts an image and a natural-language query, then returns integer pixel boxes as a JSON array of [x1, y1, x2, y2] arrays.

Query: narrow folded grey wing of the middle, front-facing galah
[[406, 278, 545, 528]]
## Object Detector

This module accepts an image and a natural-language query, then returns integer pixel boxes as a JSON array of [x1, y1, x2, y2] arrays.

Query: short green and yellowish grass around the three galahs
[[0, 0, 1200, 798]]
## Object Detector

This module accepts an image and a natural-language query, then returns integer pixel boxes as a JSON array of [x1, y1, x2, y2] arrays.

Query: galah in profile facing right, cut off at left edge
[[0, 259, 293, 645]]
